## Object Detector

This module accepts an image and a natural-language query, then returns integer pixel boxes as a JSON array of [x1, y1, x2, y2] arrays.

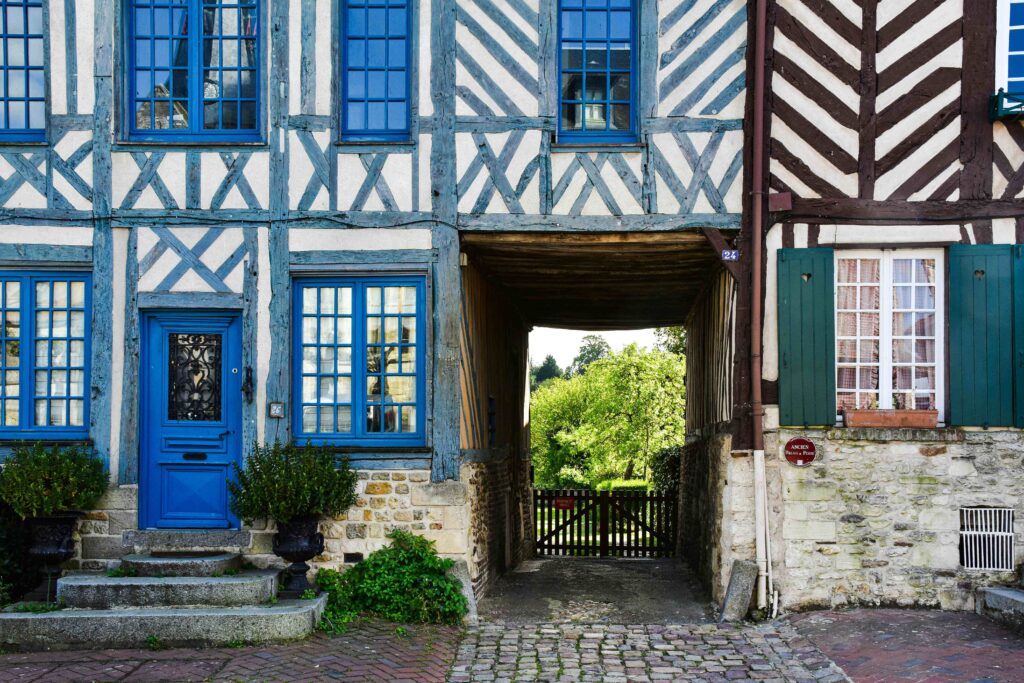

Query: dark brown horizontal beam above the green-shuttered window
[[771, 198, 1024, 223]]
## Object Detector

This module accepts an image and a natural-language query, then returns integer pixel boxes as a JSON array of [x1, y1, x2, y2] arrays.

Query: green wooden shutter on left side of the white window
[[778, 248, 836, 426]]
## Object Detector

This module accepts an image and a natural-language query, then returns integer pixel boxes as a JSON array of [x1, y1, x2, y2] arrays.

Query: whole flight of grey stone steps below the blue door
[[0, 551, 327, 650]]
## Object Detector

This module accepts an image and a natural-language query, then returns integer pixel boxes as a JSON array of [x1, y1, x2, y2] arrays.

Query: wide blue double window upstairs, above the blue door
[[125, 0, 262, 142]]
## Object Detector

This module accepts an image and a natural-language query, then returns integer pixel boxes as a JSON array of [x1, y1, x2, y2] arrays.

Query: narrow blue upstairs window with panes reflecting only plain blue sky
[[341, 0, 410, 140]]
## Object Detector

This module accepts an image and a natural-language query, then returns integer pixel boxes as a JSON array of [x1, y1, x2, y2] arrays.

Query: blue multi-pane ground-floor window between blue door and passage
[[292, 278, 426, 446]]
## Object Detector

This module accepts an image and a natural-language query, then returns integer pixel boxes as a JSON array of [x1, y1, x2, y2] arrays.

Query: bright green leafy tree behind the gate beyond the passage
[[530, 344, 686, 486]]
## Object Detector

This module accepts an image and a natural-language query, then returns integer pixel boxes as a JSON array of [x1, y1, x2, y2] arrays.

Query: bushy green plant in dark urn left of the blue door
[[0, 443, 108, 601]]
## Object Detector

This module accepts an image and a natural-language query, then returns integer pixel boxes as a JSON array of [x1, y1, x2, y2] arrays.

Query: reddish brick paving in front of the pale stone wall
[[788, 609, 1024, 683]]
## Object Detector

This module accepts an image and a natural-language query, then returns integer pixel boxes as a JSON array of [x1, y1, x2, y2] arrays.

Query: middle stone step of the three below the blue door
[[57, 569, 278, 609]]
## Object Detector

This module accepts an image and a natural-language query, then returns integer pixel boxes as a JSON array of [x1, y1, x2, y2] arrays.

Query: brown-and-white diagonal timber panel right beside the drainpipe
[[770, 0, 862, 198]]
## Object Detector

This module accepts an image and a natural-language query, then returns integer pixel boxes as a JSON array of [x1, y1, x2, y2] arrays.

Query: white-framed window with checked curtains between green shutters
[[836, 249, 945, 422]]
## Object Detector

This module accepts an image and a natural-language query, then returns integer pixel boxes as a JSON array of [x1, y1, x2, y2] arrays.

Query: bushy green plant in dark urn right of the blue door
[[227, 442, 358, 597]]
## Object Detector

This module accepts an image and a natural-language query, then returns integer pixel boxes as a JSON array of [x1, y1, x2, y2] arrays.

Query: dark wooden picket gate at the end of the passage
[[534, 488, 677, 557]]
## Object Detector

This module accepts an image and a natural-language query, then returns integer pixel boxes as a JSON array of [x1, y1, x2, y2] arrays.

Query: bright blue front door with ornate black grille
[[139, 311, 243, 528]]
